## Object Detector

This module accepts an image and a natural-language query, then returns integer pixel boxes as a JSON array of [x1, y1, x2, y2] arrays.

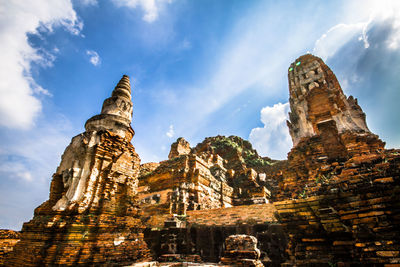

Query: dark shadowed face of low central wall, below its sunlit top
[[145, 223, 287, 266]]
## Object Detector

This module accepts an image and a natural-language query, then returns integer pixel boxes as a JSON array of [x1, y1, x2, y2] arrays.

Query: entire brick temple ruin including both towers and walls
[[0, 55, 400, 266]]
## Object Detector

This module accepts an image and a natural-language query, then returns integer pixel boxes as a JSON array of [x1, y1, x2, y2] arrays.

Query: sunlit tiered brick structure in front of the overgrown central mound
[[139, 154, 233, 216]]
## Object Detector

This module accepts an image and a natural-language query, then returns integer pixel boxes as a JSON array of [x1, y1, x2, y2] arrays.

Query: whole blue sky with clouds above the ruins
[[0, 0, 400, 229]]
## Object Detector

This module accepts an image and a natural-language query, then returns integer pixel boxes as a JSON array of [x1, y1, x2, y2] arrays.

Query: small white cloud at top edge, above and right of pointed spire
[[112, 0, 172, 23]]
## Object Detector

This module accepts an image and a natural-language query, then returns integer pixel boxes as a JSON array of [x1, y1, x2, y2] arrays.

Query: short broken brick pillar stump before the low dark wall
[[221, 235, 264, 267]]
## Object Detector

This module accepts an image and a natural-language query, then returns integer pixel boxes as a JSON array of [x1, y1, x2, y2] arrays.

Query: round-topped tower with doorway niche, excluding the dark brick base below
[[287, 54, 384, 157]]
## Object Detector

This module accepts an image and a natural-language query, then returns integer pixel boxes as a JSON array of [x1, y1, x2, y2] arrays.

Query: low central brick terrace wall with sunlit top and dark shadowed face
[[145, 204, 287, 263]]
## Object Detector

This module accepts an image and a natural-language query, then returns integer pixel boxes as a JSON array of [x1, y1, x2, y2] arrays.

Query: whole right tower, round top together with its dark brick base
[[269, 55, 400, 266]]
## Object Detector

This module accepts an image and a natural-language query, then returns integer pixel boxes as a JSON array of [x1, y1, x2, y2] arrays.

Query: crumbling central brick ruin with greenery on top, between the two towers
[[139, 136, 270, 220]]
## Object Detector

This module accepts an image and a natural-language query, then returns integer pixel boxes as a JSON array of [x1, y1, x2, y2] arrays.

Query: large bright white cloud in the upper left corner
[[0, 0, 82, 129]]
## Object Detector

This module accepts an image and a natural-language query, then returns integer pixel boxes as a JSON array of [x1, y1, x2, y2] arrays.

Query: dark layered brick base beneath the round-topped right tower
[[274, 150, 400, 266]]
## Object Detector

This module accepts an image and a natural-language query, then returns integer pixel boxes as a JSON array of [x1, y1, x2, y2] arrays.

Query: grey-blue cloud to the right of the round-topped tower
[[328, 20, 400, 151]]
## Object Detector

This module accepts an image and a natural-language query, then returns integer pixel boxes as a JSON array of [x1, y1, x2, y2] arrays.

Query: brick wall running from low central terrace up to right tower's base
[[141, 150, 400, 266]]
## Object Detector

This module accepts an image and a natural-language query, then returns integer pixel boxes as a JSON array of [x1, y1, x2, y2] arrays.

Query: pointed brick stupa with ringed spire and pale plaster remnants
[[6, 75, 149, 266]]
